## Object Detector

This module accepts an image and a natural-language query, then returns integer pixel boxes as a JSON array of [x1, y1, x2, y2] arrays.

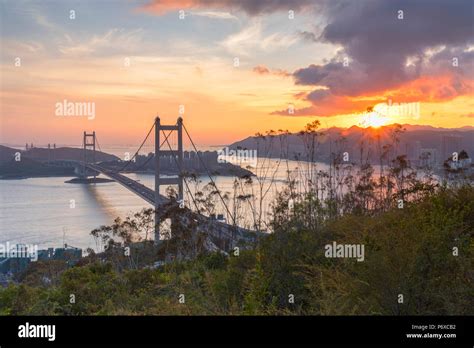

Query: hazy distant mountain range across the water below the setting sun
[[229, 124, 474, 164]]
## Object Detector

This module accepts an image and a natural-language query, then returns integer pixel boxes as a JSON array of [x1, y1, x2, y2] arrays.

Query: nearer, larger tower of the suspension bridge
[[155, 117, 184, 243]]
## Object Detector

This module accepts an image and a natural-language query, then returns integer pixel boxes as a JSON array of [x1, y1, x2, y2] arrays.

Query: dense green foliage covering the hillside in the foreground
[[0, 186, 474, 315]]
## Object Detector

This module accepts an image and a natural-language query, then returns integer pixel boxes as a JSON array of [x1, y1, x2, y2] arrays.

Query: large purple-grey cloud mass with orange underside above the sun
[[286, 0, 474, 117]]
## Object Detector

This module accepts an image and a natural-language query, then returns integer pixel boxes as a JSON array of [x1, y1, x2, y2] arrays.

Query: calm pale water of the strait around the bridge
[[0, 150, 314, 249]]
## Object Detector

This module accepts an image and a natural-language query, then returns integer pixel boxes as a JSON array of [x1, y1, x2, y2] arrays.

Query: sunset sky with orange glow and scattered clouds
[[0, 0, 474, 145]]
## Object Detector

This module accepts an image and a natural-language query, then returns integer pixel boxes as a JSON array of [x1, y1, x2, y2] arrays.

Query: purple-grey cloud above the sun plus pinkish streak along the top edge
[[144, 0, 474, 114]]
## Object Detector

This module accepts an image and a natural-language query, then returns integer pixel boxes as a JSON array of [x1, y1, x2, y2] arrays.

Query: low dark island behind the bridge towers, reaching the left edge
[[0, 145, 254, 184]]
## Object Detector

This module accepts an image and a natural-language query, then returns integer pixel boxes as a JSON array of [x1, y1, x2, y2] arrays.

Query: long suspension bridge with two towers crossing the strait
[[80, 117, 259, 252]]
